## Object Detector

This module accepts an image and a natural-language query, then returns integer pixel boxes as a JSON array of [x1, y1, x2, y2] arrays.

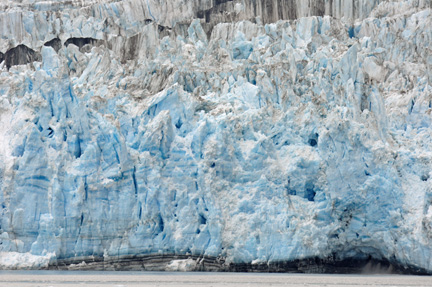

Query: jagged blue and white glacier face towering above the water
[[0, 0, 432, 272]]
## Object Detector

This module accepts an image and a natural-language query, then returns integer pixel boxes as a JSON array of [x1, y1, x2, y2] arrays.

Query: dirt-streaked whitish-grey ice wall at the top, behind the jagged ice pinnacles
[[0, 0, 390, 53]]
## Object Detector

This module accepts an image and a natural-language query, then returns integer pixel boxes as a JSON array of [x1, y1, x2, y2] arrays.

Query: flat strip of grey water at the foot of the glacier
[[0, 271, 432, 287]]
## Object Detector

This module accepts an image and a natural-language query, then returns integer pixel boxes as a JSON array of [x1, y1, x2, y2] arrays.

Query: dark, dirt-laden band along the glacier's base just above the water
[[47, 254, 432, 275]]
